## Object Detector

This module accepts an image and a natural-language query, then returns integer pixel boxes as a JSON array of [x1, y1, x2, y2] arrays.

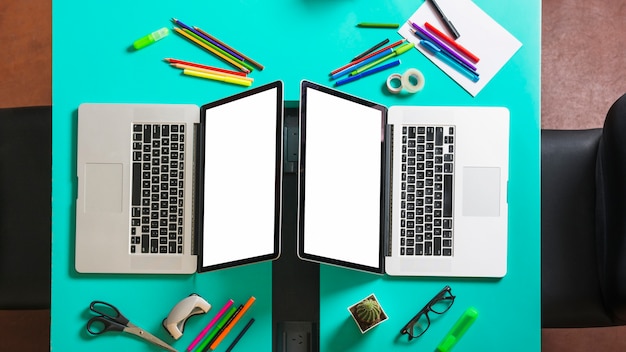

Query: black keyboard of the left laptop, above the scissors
[[129, 124, 185, 254]]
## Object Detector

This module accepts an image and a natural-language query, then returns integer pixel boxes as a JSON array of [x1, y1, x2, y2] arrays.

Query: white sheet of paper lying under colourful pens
[[398, 0, 522, 96]]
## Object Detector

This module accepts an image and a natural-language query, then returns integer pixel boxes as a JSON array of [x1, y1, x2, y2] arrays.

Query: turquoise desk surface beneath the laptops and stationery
[[51, 0, 541, 352]]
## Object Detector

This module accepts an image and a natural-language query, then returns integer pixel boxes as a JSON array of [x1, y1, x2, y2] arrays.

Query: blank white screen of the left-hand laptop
[[201, 87, 282, 267]]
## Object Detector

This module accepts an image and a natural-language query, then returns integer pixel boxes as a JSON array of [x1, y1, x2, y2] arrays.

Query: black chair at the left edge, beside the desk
[[0, 106, 52, 309]]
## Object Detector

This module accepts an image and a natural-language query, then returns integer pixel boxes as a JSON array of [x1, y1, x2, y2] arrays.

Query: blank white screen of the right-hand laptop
[[298, 81, 386, 268]]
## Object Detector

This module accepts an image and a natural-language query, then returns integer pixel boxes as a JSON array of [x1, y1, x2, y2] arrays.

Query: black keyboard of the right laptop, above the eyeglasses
[[400, 126, 454, 256]]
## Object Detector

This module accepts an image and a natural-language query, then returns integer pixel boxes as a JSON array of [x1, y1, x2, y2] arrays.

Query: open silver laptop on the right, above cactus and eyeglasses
[[298, 81, 509, 277]]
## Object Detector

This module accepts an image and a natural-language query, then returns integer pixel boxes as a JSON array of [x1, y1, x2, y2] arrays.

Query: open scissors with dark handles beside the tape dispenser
[[87, 301, 176, 352]]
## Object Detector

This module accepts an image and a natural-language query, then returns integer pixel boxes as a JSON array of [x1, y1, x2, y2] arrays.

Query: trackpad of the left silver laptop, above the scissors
[[85, 164, 124, 213]]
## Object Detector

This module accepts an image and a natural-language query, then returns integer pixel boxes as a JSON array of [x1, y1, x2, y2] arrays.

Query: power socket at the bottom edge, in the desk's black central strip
[[277, 321, 317, 352]]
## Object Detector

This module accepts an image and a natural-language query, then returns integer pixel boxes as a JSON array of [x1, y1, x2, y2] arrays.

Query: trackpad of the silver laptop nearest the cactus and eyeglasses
[[463, 167, 500, 217]]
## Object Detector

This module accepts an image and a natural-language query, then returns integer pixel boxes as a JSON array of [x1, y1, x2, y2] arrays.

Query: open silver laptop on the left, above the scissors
[[75, 81, 283, 274]]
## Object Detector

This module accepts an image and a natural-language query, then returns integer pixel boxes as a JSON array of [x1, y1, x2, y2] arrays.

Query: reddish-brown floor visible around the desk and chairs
[[0, 0, 626, 352]]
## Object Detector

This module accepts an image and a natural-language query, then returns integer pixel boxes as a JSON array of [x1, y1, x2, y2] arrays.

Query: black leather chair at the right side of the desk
[[541, 94, 626, 328]]
